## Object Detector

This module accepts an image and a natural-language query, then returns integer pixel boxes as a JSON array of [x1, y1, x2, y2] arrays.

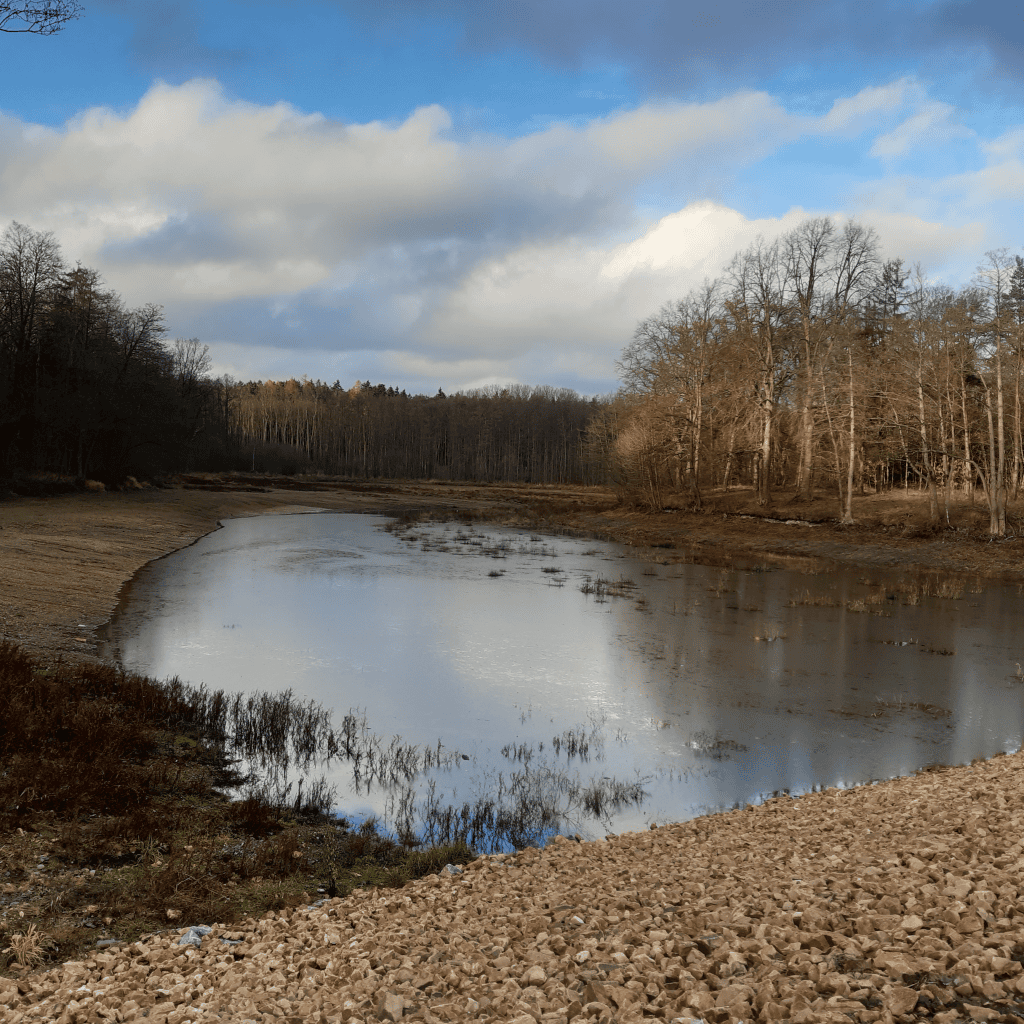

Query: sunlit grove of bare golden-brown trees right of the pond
[[606, 218, 1024, 537]]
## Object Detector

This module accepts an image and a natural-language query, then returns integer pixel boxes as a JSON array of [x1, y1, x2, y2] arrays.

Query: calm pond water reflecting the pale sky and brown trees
[[99, 514, 1024, 836]]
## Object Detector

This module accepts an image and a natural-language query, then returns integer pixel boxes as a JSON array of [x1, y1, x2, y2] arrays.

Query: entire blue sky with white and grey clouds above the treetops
[[0, 0, 1024, 394]]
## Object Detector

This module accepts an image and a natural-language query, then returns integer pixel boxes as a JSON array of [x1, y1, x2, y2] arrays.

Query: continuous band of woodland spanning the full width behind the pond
[[0, 218, 1024, 537]]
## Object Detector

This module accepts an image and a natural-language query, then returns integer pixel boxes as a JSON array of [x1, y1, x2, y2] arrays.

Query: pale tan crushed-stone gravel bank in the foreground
[[0, 754, 1024, 1024]]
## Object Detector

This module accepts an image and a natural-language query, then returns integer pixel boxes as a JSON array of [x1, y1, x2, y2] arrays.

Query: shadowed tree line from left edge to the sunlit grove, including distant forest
[[0, 222, 603, 483]]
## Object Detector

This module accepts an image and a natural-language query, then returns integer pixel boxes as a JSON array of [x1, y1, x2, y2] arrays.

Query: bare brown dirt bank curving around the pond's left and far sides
[[0, 475, 1024, 658]]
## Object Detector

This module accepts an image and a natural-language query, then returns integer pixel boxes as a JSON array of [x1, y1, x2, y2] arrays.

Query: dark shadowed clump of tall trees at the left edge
[[0, 222, 218, 481]]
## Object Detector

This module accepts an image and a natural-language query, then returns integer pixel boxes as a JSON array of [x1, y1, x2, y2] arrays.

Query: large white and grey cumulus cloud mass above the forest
[[0, 79, 1021, 389]]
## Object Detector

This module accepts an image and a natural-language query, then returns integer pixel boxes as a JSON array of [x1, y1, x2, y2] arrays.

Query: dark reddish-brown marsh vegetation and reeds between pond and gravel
[[0, 642, 473, 972]]
